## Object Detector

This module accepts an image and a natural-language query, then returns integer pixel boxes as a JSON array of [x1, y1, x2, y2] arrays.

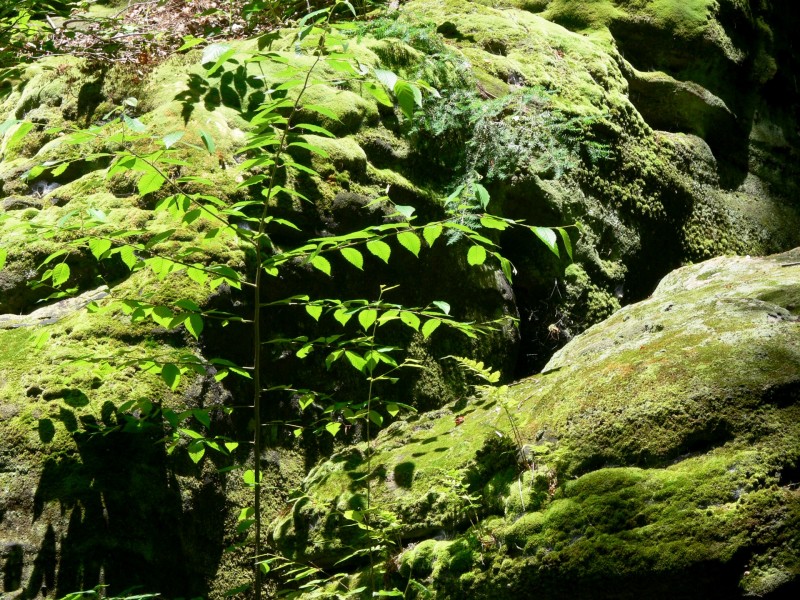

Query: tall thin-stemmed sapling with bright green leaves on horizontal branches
[[4, 4, 571, 597]]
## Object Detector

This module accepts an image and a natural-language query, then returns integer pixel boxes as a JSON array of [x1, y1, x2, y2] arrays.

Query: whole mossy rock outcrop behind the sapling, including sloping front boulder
[[0, 0, 800, 600]]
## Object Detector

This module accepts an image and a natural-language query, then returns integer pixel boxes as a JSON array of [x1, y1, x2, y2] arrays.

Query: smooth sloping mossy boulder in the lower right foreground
[[272, 250, 800, 599]]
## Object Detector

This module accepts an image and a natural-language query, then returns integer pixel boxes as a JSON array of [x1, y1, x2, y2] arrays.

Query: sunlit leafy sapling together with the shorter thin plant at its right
[[0, 0, 572, 598]]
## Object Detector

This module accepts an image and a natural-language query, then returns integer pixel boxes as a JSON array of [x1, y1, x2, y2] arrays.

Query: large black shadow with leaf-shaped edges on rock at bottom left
[[31, 410, 224, 598]]
